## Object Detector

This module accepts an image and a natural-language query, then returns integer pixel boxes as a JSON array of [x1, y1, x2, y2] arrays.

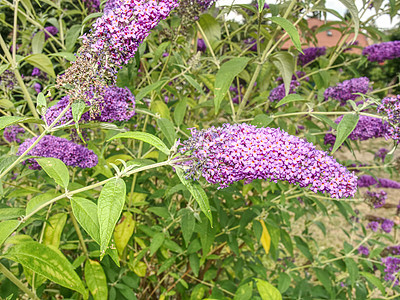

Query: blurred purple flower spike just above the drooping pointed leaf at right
[[324, 77, 371, 105]]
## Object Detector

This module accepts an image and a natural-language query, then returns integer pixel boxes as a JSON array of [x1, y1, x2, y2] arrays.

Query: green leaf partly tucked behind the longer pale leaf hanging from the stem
[[71, 197, 100, 244]]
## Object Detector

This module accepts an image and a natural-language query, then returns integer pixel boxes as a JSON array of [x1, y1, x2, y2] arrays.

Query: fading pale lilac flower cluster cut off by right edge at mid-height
[[377, 95, 400, 143]]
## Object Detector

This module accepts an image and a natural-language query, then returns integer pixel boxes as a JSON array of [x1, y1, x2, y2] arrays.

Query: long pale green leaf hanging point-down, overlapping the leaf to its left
[[97, 178, 126, 258]]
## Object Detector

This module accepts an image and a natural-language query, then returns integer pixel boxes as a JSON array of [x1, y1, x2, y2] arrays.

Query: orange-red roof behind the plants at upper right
[[282, 18, 369, 54]]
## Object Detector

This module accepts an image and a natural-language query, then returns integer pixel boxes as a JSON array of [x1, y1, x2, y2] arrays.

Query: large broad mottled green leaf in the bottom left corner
[[4, 242, 87, 297]]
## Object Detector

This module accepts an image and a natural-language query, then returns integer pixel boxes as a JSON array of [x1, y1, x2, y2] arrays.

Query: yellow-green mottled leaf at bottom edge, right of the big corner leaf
[[85, 259, 108, 300]]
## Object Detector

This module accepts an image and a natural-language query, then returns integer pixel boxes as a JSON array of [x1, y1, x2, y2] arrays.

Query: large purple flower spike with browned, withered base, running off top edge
[[57, 0, 178, 103]]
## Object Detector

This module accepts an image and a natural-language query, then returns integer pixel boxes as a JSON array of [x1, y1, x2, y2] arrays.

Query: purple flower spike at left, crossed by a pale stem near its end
[[17, 135, 98, 170]]
